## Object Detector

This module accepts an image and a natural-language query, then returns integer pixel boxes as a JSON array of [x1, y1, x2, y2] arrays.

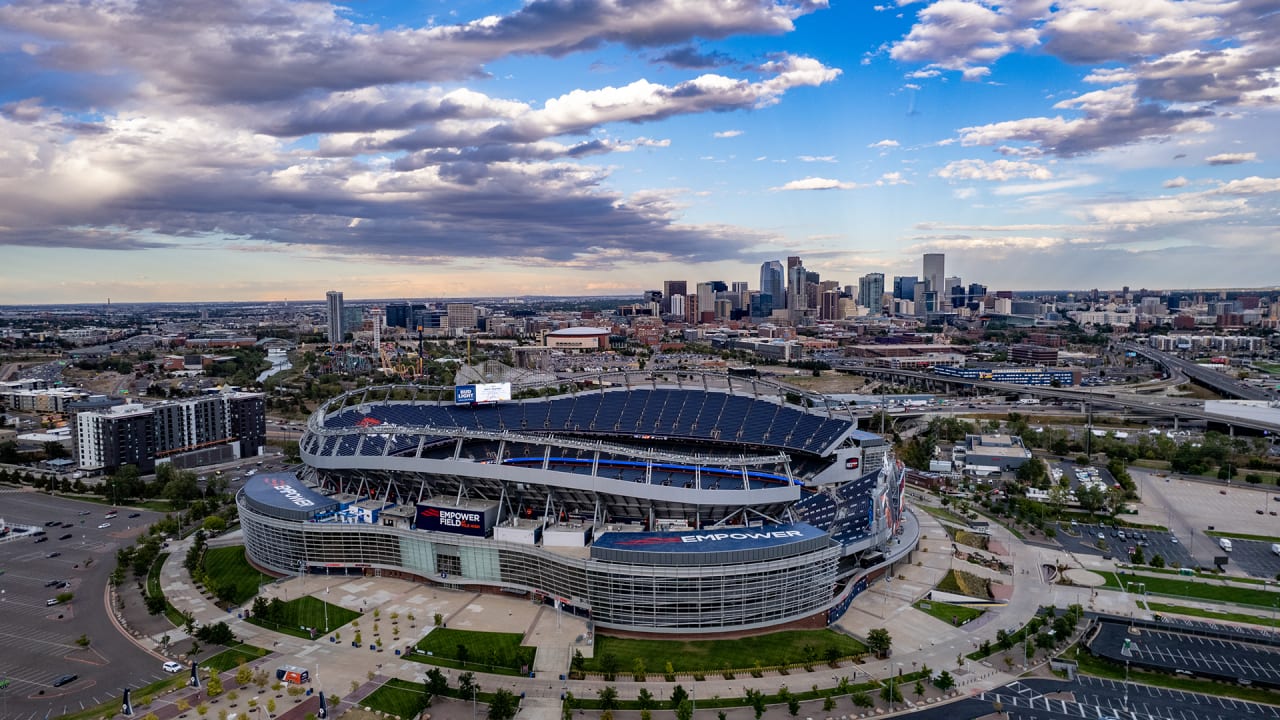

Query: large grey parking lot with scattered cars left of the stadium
[[0, 488, 164, 720]]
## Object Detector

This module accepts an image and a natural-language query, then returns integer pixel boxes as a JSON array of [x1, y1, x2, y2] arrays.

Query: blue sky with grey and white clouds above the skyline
[[0, 0, 1280, 302]]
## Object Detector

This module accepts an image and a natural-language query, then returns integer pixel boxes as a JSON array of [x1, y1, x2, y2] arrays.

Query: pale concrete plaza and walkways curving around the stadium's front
[[147, 499, 1133, 720]]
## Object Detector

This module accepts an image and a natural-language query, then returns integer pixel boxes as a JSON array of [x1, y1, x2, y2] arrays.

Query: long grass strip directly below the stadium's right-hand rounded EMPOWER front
[[584, 630, 867, 674]]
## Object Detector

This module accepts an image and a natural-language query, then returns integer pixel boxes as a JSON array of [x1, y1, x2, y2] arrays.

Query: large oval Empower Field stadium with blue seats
[[237, 373, 919, 635]]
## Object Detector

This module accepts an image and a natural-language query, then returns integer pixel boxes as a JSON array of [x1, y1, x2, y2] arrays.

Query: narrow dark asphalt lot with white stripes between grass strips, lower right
[[1089, 621, 1280, 687]]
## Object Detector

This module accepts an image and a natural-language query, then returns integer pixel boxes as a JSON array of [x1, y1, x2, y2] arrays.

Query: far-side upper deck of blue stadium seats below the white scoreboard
[[324, 389, 852, 455]]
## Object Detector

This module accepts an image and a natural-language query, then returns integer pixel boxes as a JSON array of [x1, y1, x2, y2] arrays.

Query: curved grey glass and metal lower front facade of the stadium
[[238, 493, 841, 633]]
